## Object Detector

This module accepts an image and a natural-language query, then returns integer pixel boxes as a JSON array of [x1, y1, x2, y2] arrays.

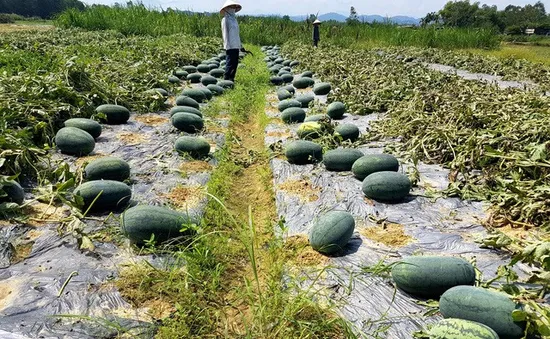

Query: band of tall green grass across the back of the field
[[56, 4, 500, 49]]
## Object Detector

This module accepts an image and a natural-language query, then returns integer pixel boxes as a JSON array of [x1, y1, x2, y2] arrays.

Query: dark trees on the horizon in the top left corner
[[0, 0, 86, 19]]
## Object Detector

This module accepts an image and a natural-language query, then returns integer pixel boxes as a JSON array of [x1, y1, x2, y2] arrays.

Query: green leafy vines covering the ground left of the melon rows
[[0, 29, 218, 176]]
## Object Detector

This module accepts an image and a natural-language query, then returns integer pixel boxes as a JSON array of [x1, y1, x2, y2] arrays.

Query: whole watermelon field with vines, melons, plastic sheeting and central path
[[0, 10, 550, 339]]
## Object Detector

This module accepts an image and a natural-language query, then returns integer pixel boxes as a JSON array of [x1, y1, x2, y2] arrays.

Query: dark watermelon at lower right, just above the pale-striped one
[[439, 286, 526, 339]]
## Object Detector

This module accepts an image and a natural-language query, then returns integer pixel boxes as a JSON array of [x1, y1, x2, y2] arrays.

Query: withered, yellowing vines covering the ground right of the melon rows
[[284, 43, 550, 234]]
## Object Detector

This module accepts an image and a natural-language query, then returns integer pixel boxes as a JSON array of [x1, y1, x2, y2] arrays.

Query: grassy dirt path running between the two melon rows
[[117, 47, 353, 339]]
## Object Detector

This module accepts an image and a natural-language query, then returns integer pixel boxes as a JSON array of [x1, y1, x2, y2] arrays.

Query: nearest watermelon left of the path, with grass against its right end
[[121, 205, 197, 245]]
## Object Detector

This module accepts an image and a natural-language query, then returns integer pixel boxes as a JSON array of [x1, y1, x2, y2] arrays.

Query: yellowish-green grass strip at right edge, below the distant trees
[[467, 43, 550, 66]]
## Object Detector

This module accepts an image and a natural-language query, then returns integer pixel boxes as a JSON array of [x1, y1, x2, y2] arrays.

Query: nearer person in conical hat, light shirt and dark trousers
[[220, 0, 243, 81]]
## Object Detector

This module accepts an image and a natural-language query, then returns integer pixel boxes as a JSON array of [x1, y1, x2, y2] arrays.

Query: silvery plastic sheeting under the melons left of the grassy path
[[0, 85, 228, 339]]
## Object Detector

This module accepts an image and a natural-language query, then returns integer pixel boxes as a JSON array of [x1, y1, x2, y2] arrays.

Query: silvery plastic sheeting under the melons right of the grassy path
[[265, 87, 528, 338]]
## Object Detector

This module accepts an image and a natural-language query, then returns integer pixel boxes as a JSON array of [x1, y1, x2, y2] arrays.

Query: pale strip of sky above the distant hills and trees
[[81, 0, 550, 18]]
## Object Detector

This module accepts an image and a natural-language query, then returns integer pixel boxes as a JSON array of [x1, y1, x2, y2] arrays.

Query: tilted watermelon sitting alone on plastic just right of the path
[[309, 211, 355, 254]]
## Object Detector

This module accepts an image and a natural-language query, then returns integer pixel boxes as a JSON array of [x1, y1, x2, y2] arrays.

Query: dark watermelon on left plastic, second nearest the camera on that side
[[74, 180, 132, 211]]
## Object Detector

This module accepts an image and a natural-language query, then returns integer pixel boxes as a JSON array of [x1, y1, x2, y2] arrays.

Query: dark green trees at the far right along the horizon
[[421, 0, 550, 34]]
